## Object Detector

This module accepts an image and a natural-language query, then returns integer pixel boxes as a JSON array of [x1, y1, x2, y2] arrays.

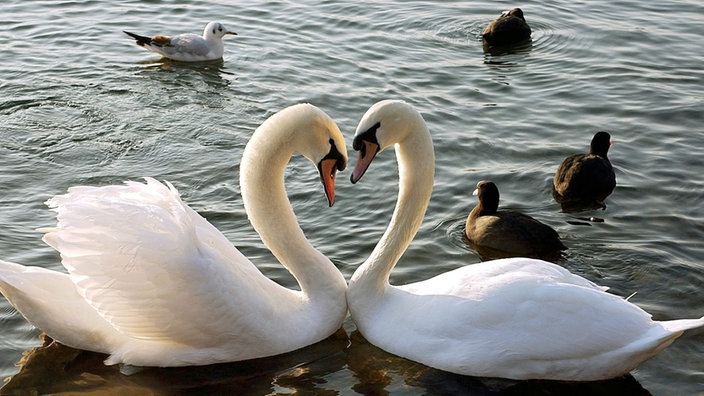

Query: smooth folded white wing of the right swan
[[398, 258, 655, 357]]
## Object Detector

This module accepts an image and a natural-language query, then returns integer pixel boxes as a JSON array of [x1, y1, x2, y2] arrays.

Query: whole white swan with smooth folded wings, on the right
[[347, 101, 704, 381]]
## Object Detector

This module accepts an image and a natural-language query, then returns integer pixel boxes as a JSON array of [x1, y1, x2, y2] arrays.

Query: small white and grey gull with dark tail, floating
[[123, 22, 237, 62]]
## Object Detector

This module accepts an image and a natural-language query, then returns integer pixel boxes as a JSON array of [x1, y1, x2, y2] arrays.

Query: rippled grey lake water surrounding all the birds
[[0, 0, 704, 395]]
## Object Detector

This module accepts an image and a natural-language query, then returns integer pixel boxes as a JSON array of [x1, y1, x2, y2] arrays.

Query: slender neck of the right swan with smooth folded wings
[[350, 116, 435, 293]]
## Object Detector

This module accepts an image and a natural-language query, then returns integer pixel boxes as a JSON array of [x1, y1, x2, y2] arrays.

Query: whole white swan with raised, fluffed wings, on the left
[[0, 104, 347, 366]]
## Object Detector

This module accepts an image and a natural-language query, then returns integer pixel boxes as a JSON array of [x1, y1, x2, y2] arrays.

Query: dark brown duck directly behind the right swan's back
[[465, 180, 567, 257]]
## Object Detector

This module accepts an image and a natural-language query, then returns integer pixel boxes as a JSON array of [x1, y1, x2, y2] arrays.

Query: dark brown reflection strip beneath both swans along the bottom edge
[[0, 329, 650, 396]]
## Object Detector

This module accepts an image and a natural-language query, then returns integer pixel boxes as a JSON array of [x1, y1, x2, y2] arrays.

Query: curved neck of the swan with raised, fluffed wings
[[240, 117, 345, 295]]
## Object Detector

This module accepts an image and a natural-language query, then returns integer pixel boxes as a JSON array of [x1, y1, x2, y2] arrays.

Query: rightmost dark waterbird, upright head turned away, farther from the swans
[[553, 131, 616, 211]]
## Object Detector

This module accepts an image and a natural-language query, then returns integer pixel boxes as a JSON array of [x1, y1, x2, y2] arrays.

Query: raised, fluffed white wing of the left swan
[[44, 179, 274, 346]]
